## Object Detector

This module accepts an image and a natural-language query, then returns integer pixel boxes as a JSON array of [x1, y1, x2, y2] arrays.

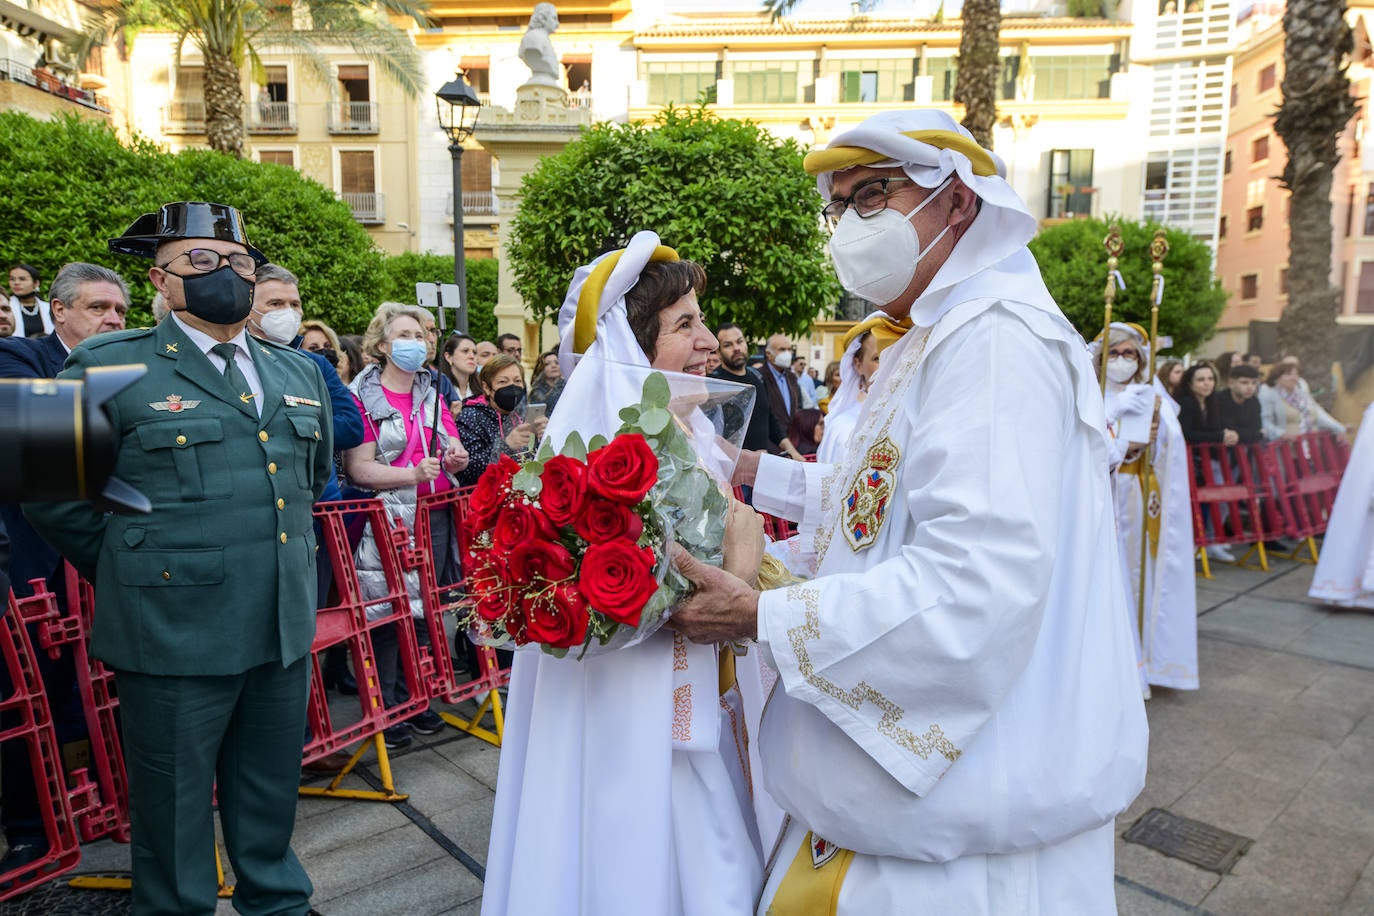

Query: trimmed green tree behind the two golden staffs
[[1031, 218, 1226, 354]]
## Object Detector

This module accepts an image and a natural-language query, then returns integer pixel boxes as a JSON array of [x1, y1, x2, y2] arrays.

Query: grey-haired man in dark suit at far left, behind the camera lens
[[0, 262, 129, 873]]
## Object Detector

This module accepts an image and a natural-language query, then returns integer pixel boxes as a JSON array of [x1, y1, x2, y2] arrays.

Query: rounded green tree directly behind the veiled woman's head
[[508, 107, 840, 338]]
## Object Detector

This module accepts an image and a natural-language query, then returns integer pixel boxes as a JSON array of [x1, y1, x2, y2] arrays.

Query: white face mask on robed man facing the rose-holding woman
[[830, 177, 952, 305]]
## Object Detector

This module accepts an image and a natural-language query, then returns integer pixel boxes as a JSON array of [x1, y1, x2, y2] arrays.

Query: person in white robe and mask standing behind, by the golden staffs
[[1091, 321, 1198, 696]]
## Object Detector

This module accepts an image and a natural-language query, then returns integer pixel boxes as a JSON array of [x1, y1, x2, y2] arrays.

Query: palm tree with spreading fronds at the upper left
[[78, 0, 429, 158]]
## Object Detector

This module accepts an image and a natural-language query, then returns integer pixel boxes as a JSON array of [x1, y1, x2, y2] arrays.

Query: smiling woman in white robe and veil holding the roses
[[482, 232, 782, 916]]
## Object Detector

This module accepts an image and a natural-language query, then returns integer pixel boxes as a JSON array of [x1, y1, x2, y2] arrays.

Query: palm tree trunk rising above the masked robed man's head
[[764, 0, 1002, 150]]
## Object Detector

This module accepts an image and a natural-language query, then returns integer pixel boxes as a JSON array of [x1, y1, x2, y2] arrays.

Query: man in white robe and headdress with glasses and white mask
[[672, 111, 1147, 916]]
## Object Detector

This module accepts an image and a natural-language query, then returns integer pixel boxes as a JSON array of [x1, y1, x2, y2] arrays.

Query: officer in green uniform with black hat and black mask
[[29, 203, 334, 916]]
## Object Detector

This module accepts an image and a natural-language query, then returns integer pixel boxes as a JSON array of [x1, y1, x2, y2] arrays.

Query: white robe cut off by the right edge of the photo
[[1308, 404, 1374, 608]]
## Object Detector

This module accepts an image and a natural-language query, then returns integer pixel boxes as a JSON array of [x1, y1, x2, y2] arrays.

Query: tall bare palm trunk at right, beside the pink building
[[1274, 0, 1355, 378]]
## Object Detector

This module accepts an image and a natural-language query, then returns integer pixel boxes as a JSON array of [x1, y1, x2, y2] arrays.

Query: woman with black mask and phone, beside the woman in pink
[[458, 353, 548, 486]]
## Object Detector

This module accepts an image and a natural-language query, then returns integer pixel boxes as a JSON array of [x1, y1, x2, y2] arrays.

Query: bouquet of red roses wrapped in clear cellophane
[[463, 364, 753, 658]]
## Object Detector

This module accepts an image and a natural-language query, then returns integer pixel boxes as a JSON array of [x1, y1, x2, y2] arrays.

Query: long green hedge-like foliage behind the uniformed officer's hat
[[0, 111, 387, 331]]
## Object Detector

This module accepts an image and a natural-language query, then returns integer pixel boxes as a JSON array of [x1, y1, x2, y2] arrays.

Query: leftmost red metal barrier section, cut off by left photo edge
[[0, 589, 82, 901]]
